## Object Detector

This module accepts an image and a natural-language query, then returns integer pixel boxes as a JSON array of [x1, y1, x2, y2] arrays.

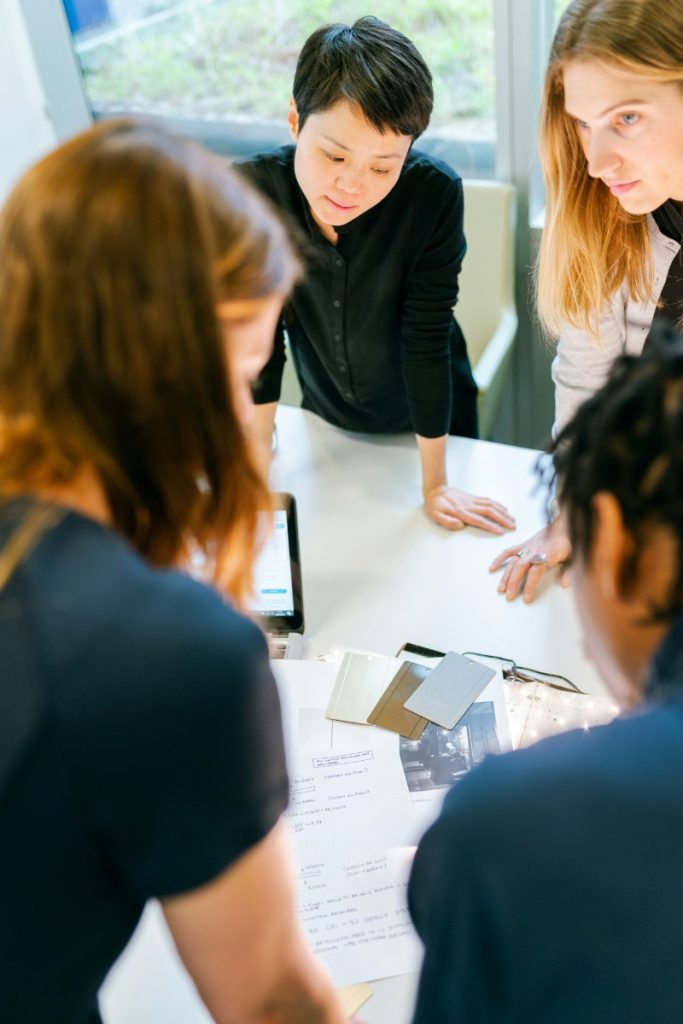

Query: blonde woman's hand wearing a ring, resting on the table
[[488, 519, 571, 604]]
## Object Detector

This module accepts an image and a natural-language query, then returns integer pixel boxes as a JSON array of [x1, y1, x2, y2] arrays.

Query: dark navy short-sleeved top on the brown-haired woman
[[0, 503, 287, 1024]]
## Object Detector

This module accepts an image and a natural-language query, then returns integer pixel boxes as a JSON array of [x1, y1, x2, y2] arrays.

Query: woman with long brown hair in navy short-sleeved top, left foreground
[[0, 121, 343, 1024]]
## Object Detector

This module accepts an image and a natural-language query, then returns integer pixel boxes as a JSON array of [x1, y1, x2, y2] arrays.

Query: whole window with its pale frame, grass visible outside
[[22, 0, 568, 444]]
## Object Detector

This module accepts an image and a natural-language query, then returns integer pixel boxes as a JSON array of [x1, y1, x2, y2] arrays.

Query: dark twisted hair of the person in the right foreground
[[551, 325, 683, 622]]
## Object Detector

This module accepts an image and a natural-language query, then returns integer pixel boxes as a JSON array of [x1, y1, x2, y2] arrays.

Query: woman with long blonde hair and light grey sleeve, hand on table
[[490, 0, 683, 601]]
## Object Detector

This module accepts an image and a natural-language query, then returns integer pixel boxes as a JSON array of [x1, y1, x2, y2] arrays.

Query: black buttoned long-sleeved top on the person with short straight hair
[[240, 145, 476, 437]]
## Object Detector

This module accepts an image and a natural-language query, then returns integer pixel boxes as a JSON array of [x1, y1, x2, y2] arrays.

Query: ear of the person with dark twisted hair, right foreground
[[591, 490, 638, 603]]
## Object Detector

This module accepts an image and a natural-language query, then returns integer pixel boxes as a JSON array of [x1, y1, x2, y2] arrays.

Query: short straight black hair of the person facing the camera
[[293, 16, 434, 138]]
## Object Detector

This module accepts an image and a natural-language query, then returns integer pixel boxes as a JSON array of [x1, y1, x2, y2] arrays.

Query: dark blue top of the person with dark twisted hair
[[409, 616, 683, 1024]]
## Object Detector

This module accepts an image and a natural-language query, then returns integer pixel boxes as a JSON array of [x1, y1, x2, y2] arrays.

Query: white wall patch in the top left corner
[[0, 0, 56, 202]]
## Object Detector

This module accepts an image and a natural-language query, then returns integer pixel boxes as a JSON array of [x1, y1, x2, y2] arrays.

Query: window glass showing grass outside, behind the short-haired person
[[58, 0, 496, 174]]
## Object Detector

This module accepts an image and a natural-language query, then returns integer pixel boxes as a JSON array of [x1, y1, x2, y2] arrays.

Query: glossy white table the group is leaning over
[[102, 407, 604, 1024]]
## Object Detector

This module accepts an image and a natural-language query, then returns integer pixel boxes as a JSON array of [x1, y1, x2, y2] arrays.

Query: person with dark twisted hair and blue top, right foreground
[[410, 337, 683, 1024]]
